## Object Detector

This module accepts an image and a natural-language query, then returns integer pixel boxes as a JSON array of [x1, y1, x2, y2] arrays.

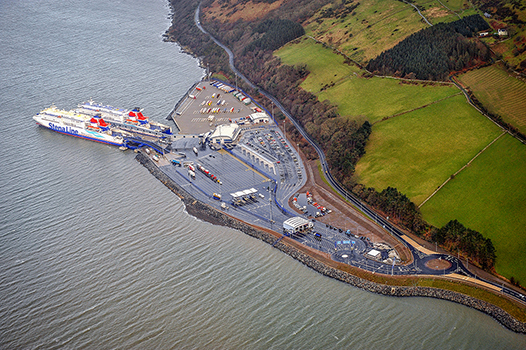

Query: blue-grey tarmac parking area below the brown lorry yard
[[151, 126, 386, 255]]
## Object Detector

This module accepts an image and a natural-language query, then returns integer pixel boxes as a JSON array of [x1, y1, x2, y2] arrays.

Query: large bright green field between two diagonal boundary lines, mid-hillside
[[356, 96, 501, 205]]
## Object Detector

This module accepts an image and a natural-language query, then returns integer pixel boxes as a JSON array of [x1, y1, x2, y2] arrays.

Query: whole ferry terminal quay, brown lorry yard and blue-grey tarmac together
[[138, 80, 405, 274]]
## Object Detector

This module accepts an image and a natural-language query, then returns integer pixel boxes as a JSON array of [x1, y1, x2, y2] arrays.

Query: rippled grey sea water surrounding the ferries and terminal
[[0, 0, 526, 349]]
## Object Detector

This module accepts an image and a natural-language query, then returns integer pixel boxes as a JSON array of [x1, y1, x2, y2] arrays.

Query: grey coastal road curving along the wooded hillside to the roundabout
[[194, 3, 526, 304]]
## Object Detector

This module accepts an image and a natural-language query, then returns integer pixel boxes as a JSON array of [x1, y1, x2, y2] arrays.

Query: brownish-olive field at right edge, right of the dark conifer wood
[[459, 65, 526, 134]]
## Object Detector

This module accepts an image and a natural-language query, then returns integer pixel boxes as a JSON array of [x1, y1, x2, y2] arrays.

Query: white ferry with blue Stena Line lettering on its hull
[[33, 106, 125, 146]]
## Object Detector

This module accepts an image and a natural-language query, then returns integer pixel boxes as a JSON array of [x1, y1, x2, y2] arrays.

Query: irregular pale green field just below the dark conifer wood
[[275, 38, 459, 123]]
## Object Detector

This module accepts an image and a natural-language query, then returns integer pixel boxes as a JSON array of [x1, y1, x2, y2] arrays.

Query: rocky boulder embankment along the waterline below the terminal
[[135, 153, 526, 334]]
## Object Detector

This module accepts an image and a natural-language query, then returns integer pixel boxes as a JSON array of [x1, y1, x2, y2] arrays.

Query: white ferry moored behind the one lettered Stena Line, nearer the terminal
[[76, 100, 173, 139]]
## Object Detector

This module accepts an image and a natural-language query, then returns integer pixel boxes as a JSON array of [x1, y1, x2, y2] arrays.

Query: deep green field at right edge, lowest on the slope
[[421, 135, 526, 285]]
